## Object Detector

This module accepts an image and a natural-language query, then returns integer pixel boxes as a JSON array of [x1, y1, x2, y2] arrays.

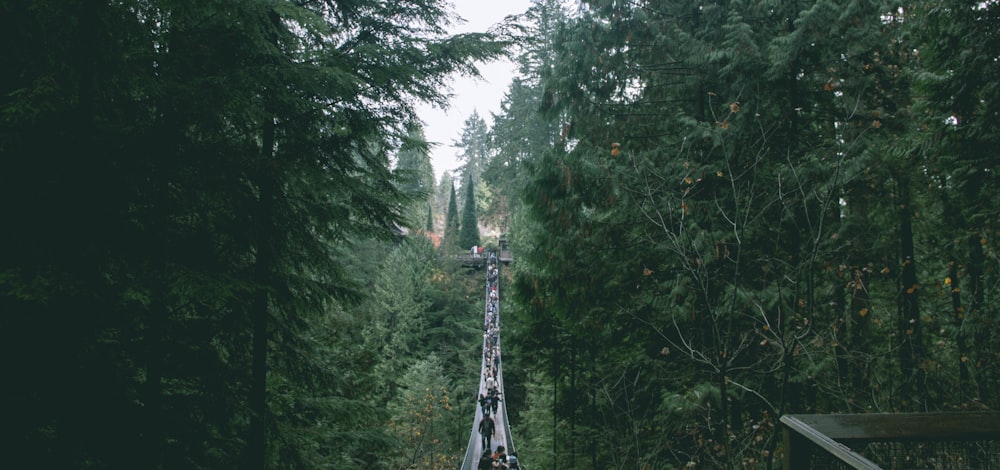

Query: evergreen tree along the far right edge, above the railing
[[912, 1, 1000, 408]]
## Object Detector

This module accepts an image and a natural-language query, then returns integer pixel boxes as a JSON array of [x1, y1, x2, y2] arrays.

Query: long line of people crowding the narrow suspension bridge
[[477, 253, 520, 470]]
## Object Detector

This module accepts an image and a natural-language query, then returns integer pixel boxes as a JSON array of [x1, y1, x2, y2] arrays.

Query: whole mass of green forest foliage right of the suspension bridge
[[498, 1, 997, 468]]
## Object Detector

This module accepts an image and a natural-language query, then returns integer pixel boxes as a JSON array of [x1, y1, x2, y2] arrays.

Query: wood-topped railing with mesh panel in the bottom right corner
[[781, 411, 1000, 470]]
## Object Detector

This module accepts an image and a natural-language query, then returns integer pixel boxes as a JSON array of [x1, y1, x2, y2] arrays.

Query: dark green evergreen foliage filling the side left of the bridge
[[0, 1, 504, 468]]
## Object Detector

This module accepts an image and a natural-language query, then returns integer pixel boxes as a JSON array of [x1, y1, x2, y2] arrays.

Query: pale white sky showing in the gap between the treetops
[[417, 0, 531, 179]]
